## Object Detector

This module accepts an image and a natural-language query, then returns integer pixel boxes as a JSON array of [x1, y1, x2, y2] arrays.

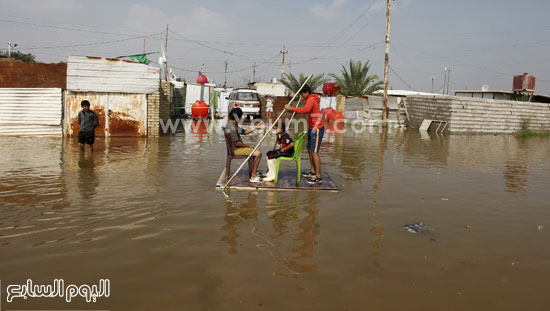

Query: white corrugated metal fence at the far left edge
[[0, 88, 63, 136]]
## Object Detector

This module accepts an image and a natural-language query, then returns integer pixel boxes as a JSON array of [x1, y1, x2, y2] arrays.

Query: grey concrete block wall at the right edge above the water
[[406, 96, 550, 134]]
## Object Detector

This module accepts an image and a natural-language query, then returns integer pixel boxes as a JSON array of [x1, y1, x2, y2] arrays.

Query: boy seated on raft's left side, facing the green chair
[[225, 108, 265, 183]]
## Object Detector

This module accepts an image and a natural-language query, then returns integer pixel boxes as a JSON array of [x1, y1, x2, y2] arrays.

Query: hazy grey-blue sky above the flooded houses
[[0, 0, 550, 94]]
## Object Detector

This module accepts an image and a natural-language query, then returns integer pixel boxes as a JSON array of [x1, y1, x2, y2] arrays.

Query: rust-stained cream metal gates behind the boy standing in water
[[64, 91, 147, 137]]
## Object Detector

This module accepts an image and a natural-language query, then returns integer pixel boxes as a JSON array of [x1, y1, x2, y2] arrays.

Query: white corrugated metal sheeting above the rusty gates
[[67, 56, 160, 94]]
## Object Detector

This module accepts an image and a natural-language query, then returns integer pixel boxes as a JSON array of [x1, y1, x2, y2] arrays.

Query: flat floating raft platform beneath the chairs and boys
[[216, 169, 339, 192]]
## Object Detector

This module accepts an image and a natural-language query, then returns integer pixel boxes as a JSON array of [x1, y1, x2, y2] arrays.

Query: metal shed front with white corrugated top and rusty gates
[[65, 56, 160, 136]]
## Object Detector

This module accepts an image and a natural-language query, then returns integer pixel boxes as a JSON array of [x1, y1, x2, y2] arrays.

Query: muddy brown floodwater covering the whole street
[[0, 120, 550, 311]]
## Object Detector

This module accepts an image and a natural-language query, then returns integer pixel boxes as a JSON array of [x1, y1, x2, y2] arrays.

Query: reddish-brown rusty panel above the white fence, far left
[[0, 58, 67, 89]]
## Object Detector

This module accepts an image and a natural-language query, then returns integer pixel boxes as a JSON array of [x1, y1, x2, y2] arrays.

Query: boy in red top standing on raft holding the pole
[[285, 84, 325, 184]]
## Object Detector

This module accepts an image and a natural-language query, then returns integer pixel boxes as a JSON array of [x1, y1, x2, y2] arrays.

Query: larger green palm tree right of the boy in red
[[330, 59, 384, 96]]
